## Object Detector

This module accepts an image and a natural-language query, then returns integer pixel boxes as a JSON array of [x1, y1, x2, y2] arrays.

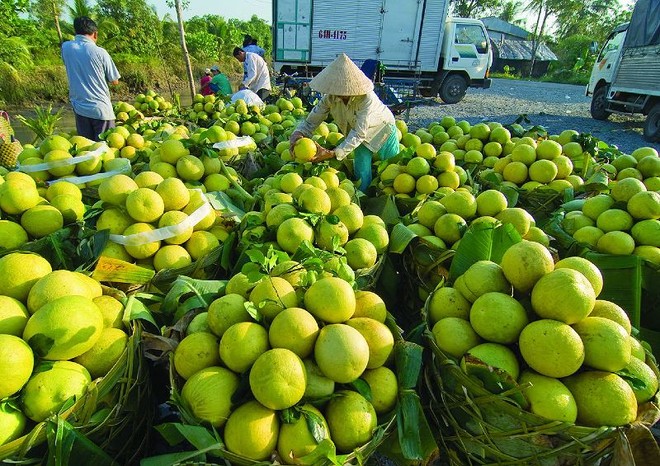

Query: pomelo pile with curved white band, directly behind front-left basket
[[95, 172, 229, 271]]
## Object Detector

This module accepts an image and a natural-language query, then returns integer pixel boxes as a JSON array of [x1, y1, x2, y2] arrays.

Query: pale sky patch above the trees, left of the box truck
[[147, 0, 273, 24]]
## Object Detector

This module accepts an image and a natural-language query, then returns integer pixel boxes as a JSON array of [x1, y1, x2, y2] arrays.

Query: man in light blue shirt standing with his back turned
[[62, 16, 121, 141]]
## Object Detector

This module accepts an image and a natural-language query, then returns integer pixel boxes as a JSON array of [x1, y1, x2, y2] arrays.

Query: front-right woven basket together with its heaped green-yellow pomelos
[[423, 227, 660, 465]]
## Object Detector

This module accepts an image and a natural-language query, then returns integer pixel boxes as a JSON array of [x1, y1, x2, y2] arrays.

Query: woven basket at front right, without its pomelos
[[423, 302, 660, 466]]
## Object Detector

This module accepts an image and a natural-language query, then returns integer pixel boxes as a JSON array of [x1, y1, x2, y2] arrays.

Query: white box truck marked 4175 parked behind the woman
[[273, 0, 493, 103]]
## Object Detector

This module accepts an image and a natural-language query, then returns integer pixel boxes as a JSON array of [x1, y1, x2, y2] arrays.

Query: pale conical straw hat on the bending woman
[[309, 53, 374, 96]]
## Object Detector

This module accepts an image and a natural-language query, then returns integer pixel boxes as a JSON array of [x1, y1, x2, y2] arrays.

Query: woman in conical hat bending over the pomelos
[[289, 53, 399, 192]]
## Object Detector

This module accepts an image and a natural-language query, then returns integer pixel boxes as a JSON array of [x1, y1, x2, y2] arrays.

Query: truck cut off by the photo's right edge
[[586, 0, 660, 142]]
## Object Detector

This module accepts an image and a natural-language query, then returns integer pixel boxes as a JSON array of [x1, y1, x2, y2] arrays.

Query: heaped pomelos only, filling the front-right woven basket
[[427, 240, 658, 427]]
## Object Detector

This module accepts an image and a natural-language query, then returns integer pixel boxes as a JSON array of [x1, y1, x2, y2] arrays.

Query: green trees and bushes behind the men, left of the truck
[[0, 0, 272, 107]]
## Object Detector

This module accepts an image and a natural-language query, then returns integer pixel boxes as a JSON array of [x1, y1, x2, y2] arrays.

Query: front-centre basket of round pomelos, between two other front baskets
[[143, 276, 434, 465]]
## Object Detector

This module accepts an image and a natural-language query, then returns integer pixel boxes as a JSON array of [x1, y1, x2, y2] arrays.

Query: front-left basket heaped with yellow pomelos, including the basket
[[0, 252, 152, 464]]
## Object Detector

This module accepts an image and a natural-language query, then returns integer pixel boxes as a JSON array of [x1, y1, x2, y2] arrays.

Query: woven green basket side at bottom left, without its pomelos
[[0, 321, 153, 465]]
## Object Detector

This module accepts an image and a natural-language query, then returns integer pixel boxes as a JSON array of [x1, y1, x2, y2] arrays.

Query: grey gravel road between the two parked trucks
[[402, 79, 660, 153]]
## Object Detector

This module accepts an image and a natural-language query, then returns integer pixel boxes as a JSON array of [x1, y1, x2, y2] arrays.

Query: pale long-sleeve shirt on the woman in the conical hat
[[296, 91, 394, 160]]
